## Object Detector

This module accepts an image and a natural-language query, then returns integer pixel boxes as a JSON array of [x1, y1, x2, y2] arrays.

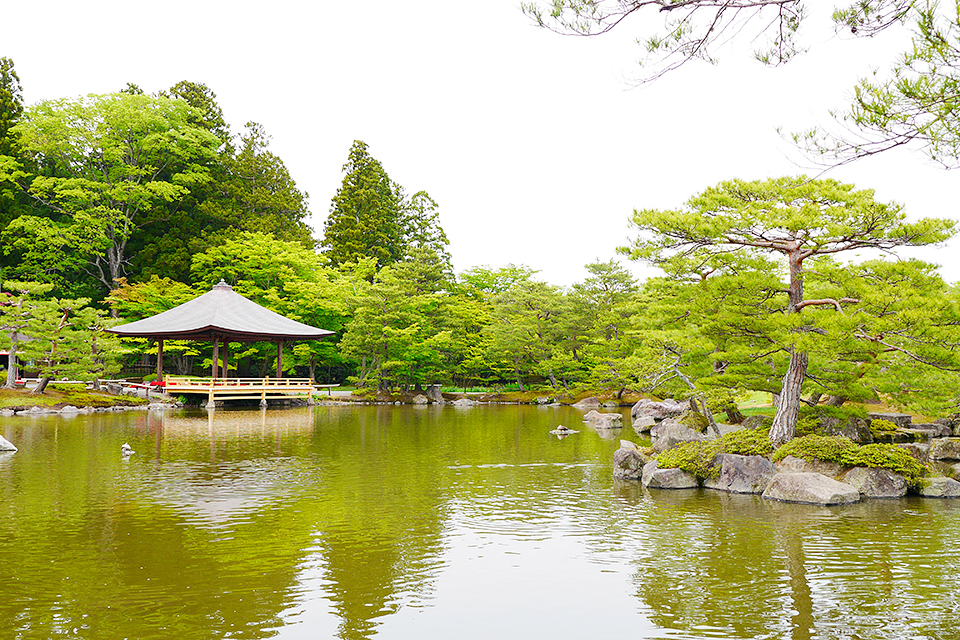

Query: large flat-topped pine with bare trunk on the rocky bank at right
[[624, 177, 954, 444]]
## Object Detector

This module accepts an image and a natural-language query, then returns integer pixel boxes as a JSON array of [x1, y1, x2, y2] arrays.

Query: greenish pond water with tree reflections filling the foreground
[[0, 406, 960, 640]]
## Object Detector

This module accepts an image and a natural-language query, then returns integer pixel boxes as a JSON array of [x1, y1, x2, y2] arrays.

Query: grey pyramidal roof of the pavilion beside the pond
[[109, 280, 335, 342]]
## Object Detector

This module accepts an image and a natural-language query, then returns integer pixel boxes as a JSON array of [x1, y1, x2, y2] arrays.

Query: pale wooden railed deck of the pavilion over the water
[[163, 376, 314, 406]]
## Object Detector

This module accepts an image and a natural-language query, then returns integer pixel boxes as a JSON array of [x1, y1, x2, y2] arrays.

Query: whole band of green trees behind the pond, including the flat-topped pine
[[0, 59, 960, 432]]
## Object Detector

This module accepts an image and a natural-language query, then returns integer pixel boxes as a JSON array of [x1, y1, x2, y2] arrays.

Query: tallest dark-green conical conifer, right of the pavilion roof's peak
[[320, 140, 405, 267]]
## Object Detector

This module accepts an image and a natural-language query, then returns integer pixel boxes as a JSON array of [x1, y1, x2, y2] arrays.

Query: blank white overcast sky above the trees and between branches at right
[[0, 0, 960, 285]]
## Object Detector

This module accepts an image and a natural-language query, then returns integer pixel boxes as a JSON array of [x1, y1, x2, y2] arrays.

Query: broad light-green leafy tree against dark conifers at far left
[[6, 93, 219, 290]]
